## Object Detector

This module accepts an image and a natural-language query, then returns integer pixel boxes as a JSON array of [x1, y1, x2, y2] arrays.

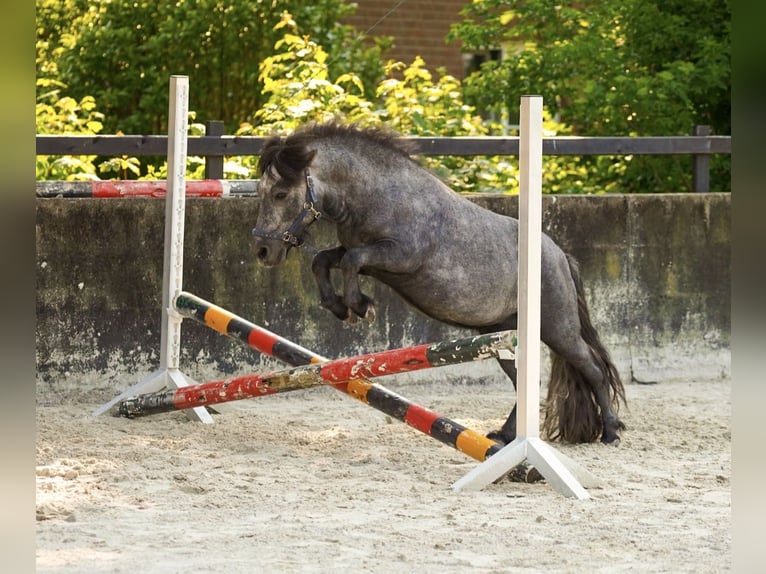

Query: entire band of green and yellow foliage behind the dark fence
[[37, 0, 730, 193]]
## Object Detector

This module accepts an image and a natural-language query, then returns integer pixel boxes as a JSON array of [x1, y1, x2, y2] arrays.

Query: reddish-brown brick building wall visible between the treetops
[[346, 0, 467, 79]]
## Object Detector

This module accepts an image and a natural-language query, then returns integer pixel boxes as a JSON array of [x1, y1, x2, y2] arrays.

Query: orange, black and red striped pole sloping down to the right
[[164, 291, 515, 461]]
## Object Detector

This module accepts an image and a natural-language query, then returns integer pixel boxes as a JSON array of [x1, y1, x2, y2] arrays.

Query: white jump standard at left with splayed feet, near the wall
[[93, 76, 213, 424]]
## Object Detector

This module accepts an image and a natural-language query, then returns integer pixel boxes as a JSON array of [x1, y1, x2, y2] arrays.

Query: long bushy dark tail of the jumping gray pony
[[542, 255, 627, 443]]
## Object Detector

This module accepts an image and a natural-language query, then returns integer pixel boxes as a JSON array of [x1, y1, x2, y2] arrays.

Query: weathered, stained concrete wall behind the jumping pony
[[36, 194, 731, 402]]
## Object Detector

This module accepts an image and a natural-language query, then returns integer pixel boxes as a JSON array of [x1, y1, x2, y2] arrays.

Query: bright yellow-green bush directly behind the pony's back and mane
[[237, 13, 517, 195]]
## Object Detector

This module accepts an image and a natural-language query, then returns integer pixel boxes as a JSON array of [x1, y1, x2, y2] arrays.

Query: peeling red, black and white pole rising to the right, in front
[[114, 331, 514, 417]]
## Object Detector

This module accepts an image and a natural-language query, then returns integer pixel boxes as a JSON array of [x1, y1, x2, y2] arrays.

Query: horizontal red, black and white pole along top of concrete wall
[[35, 179, 258, 199]]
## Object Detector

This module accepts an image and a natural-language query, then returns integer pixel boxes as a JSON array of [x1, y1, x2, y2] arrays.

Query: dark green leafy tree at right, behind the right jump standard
[[450, 0, 731, 192]]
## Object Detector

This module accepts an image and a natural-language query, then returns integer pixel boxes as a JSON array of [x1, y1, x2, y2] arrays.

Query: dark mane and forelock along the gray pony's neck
[[258, 121, 415, 182]]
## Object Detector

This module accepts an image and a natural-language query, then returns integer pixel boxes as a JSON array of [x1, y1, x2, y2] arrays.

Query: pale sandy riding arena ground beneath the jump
[[37, 381, 731, 574]]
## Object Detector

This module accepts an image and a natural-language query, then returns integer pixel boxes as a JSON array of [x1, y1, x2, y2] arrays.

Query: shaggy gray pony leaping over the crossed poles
[[253, 122, 625, 444]]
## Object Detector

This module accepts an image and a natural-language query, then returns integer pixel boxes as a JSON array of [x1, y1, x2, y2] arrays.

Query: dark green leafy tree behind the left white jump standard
[[37, 0, 382, 134]]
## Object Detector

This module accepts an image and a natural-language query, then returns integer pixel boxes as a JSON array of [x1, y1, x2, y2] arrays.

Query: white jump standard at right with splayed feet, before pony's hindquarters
[[453, 96, 598, 500]]
